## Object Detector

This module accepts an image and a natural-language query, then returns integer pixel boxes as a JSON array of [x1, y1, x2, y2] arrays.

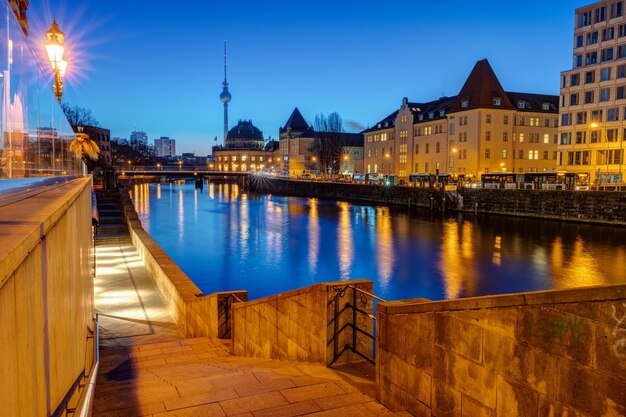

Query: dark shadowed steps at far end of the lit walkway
[[96, 191, 130, 245]]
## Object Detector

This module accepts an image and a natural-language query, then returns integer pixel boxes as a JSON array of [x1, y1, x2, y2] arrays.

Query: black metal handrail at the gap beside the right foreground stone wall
[[328, 284, 387, 366]]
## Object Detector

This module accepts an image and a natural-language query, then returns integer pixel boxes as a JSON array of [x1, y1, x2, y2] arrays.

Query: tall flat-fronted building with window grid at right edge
[[558, 0, 626, 185]]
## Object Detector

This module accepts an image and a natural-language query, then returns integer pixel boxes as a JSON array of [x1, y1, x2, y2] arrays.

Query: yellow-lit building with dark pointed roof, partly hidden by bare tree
[[280, 107, 364, 177]]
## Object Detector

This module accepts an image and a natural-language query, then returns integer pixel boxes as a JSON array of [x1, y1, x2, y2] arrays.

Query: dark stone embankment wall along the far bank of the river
[[247, 176, 626, 225]]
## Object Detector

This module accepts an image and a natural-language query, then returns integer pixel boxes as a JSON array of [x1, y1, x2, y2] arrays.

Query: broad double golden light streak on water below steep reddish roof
[[438, 221, 476, 299]]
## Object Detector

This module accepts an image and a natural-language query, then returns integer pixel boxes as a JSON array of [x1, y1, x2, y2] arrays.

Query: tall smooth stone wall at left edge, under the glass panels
[[0, 179, 95, 417]]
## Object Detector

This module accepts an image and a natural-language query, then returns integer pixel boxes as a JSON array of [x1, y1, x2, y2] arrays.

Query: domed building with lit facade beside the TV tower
[[213, 120, 280, 172]]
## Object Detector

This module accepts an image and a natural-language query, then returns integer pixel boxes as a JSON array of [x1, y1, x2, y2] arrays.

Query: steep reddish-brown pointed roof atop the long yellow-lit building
[[450, 59, 514, 113]]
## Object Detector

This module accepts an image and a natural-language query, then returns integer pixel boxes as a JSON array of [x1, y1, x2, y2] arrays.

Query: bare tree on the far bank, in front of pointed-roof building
[[310, 112, 343, 174]]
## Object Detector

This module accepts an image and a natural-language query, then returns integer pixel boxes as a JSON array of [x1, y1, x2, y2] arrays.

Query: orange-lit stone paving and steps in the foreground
[[93, 338, 410, 417]]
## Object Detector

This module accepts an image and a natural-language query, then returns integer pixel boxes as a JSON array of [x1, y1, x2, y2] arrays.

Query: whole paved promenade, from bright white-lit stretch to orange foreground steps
[[93, 241, 410, 417]]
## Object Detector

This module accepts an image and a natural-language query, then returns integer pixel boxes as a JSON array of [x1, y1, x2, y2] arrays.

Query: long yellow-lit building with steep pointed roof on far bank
[[364, 60, 558, 180]]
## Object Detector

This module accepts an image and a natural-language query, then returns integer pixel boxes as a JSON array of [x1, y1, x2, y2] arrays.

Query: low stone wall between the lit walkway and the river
[[120, 189, 248, 337]]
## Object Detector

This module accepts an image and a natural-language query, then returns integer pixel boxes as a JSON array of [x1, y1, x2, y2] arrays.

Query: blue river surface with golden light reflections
[[132, 184, 626, 299]]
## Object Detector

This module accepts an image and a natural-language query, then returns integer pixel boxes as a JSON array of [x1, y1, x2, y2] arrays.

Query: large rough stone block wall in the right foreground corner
[[376, 285, 626, 417]]
